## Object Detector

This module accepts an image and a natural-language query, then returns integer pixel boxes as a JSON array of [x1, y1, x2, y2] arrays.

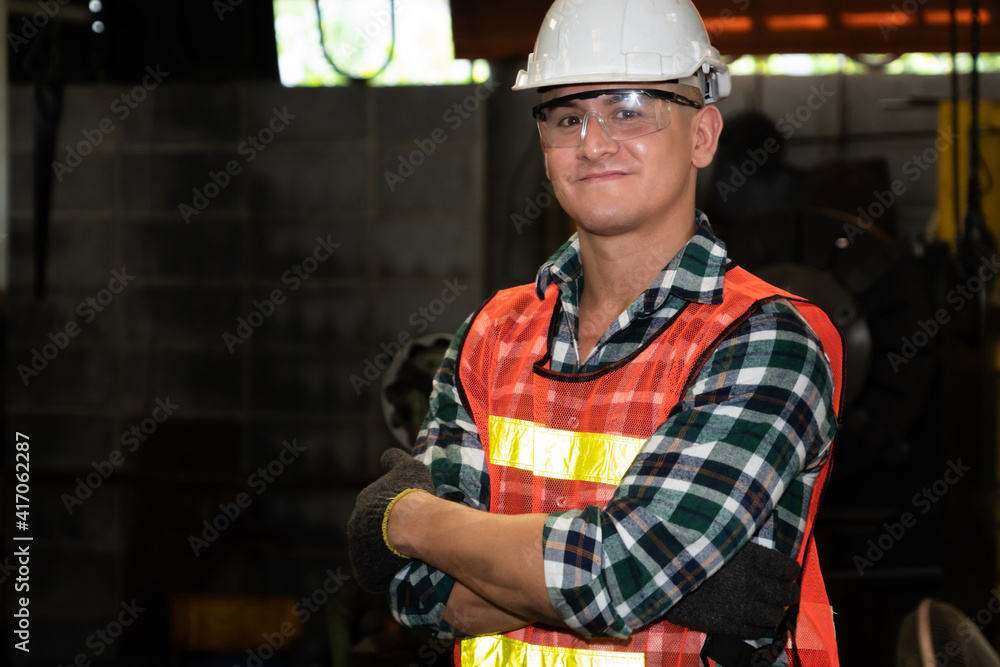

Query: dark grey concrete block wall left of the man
[[6, 77, 489, 664]]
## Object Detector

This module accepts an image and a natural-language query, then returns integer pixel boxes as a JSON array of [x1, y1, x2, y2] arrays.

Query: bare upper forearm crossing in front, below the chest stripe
[[388, 493, 563, 625]]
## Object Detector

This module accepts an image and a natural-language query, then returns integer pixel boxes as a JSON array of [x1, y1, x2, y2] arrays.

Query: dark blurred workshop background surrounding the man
[[0, 0, 1000, 667]]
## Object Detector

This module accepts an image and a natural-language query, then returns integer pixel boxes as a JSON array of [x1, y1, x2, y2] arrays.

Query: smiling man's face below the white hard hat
[[542, 83, 717, 235]]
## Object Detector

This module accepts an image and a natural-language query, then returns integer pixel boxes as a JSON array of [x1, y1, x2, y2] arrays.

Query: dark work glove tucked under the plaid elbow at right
[[666, 542, 801, 639]]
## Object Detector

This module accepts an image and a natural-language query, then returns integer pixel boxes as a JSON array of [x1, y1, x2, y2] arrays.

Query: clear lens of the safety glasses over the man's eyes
[[538, 90, 670, 148]]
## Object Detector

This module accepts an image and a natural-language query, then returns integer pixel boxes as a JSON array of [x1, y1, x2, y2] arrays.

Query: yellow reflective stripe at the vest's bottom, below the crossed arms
[[459, 635, 646, 667]]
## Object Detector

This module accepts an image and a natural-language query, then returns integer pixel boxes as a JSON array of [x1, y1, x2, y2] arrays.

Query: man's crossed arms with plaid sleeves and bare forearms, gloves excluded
[[388, 304, 835, 637]]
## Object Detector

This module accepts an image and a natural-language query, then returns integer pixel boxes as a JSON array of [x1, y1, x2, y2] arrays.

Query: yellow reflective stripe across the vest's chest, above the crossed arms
[[489, 415, 646, 486]]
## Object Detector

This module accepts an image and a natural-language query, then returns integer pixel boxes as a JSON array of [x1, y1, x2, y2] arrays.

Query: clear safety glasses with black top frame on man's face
[[531, 88, 702, 148]]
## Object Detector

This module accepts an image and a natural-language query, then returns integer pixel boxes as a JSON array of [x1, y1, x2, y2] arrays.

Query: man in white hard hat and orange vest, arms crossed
[[349, 0, 842, 667]]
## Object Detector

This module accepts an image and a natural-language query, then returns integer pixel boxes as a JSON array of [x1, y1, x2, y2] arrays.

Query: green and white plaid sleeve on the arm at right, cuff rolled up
[[544, 301, 836, 638]]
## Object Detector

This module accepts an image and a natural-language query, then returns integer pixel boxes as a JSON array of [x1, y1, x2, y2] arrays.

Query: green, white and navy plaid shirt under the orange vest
[[389, 214, 837, 638]]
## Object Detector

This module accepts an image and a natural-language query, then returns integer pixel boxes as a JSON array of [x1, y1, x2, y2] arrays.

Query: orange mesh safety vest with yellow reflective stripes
[[455, 267, 843, 667]]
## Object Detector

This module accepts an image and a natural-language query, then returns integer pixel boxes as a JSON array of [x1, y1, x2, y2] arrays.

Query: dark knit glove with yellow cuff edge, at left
[[347, 448, 434, 593]]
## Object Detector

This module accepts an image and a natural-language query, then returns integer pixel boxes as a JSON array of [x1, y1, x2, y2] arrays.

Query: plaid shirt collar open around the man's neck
[[535, 211, 729, 315]]
